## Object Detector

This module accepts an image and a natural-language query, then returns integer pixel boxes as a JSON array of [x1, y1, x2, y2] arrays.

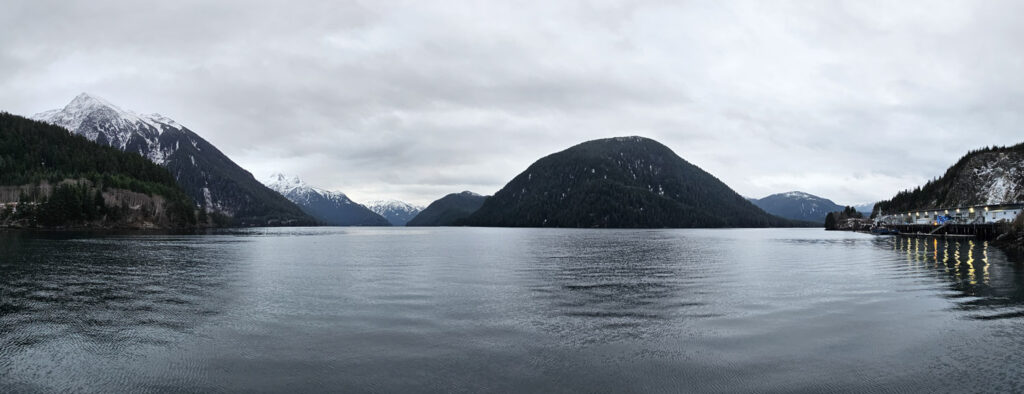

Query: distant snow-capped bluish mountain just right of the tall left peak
[[263, 174, 391, 226]]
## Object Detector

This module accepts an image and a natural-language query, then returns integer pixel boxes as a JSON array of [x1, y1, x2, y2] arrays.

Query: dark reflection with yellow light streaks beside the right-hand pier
[[892, 236, 1024, 319]]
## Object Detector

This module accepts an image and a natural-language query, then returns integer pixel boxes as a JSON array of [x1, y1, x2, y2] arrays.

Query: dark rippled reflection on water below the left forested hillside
[[0, 232, 245, 392]]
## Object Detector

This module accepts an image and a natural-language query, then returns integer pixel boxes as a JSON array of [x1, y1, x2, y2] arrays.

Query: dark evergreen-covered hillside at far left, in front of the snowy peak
[[0, 113, 197, 228]]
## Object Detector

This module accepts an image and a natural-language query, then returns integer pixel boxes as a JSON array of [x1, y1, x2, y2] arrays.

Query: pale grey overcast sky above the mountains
[[0, 0, 1024, 204]]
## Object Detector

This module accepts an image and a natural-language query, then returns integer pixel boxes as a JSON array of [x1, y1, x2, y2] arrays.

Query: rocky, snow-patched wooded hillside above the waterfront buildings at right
[[873, 143, 1024, 215]]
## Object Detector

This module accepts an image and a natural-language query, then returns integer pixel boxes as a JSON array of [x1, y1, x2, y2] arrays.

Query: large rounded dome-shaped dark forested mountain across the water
[[461, 137, 793, 227]]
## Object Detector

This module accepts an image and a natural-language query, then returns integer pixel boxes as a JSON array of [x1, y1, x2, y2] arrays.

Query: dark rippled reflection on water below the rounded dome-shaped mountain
[[524, 231, 711, 344]]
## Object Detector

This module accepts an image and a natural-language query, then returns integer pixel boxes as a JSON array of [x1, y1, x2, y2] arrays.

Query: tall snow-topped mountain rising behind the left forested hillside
[[34, 93, 315, 225]]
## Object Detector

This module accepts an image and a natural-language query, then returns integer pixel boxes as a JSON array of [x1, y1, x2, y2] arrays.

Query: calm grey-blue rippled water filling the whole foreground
[[0, 228, 1024, 393]]
